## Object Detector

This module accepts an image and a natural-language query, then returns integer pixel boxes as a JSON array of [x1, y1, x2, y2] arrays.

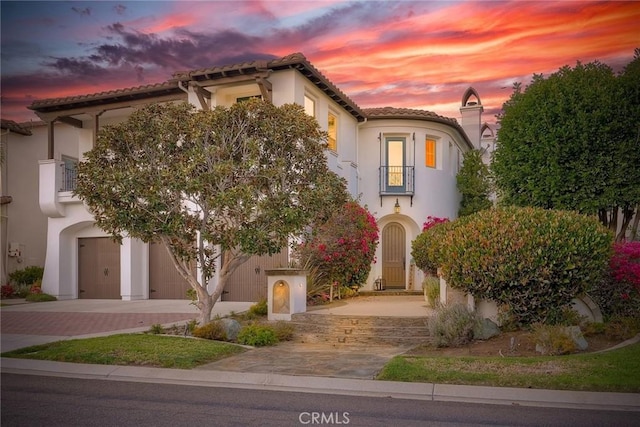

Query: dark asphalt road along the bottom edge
[[0, 374, 638, 427]]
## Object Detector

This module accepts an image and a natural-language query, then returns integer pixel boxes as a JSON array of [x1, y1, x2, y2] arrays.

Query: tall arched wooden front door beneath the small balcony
[[382, 222, 407, 289]]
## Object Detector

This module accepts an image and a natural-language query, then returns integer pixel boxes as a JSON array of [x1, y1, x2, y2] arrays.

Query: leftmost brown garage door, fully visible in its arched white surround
[[78, 237, 121, 299]]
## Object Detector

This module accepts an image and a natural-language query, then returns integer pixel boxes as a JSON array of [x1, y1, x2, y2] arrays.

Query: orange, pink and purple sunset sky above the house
[[0, 0, 640, 122]]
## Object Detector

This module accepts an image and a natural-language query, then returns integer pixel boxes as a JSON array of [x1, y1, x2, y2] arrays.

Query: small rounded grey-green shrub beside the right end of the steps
[[428, 304, 480, 347]]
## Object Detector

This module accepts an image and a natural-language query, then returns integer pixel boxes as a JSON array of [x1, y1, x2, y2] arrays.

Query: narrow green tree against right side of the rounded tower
[[456, 150, 493, 216]]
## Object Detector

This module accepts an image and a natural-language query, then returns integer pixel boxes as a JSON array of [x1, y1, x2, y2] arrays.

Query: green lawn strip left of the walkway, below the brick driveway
[[2, 334, 244, 369]]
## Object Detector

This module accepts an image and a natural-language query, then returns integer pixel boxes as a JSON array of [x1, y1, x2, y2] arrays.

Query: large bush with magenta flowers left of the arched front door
[[296, 202, 378, 287]]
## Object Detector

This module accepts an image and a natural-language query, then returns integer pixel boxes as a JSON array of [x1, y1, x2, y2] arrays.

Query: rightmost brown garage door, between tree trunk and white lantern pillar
[[222, 248, 289, 302]]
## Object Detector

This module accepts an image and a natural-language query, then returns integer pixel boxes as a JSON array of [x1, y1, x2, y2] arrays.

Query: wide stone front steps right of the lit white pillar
[[291, 313, 429, 346]]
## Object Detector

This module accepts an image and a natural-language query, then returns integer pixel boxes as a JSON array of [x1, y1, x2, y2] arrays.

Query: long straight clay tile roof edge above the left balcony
[[28, 81, 181, 112]]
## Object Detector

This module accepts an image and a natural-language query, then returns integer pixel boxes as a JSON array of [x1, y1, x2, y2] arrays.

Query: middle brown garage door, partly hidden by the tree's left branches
[[149, 243, 195, 299]]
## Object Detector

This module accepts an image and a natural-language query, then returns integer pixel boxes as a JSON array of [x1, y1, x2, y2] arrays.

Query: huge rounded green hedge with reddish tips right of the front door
[[442, 207, 613, 324]]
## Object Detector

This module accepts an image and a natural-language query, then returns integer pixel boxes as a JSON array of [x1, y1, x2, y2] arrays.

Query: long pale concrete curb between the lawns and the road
[[0, 358, 640, 412]]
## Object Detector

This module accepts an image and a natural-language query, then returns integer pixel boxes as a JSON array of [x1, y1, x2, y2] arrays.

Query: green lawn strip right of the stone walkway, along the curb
[[378, 343, 640, 393]]
